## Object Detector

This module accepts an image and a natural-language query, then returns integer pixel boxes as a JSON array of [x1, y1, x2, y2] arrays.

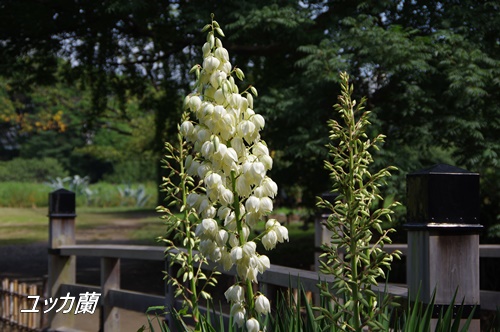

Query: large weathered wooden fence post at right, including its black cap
[[405, 164, 482, 332]]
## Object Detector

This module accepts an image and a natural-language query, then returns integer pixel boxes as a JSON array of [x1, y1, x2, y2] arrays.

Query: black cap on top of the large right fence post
[[405, 164, 482, 229]]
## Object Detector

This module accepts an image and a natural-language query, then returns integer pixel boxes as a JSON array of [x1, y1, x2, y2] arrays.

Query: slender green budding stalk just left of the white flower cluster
[[157, 112, 220, 330]]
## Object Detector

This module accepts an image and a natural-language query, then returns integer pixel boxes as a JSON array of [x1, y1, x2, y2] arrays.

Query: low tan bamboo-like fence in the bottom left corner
[[0, 279, 43, 331]]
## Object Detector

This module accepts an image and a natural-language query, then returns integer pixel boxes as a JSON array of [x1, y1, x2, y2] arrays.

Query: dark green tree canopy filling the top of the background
[[0, 0, 500, 231]]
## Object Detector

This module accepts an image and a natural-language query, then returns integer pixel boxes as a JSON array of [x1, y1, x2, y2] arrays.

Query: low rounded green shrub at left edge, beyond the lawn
[[0, 158, 67, 182]]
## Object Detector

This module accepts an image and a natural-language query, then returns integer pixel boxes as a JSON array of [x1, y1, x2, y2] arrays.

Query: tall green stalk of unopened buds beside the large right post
[[318, 73, 401, 331]]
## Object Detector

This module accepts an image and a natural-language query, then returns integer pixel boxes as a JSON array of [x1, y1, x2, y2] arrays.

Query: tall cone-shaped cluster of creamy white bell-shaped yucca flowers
[[180, 22, 288, 331]]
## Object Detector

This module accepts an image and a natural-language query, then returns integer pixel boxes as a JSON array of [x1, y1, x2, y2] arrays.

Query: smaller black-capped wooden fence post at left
[[47, 189, 76, 329]]
